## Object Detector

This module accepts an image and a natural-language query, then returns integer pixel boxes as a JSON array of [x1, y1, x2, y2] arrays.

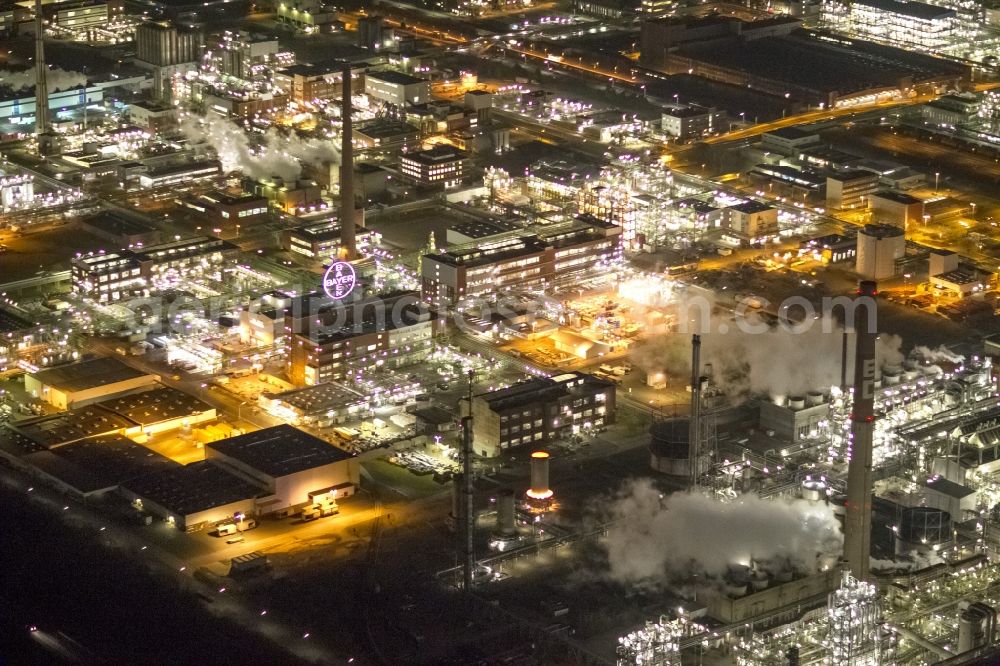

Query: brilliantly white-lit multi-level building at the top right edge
[[823, 0, 958, 51]]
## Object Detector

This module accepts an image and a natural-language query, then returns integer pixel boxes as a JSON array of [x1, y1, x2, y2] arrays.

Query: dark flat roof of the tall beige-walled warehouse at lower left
[[208, 424, 350, 477]]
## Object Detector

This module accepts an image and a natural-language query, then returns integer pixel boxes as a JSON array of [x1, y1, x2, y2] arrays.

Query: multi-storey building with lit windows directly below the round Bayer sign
[[284, 291, 434, 386]]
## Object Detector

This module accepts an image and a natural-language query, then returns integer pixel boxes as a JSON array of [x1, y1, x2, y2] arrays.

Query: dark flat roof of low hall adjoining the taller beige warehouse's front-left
[[121, 460, 263, 516]]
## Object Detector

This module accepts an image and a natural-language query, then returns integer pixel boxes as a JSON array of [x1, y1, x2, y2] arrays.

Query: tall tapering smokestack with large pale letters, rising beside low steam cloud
[[844, 280, 878, 580]]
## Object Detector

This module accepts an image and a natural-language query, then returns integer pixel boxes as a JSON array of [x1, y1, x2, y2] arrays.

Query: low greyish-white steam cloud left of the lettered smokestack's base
[[605, 479, 843, 585]]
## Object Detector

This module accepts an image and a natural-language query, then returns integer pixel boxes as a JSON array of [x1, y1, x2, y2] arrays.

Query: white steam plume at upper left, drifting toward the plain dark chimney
[[181, 115, 340, 181]]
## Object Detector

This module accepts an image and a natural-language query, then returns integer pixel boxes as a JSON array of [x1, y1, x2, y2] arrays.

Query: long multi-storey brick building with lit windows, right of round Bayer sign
[[420, 215, 622, 307]]
